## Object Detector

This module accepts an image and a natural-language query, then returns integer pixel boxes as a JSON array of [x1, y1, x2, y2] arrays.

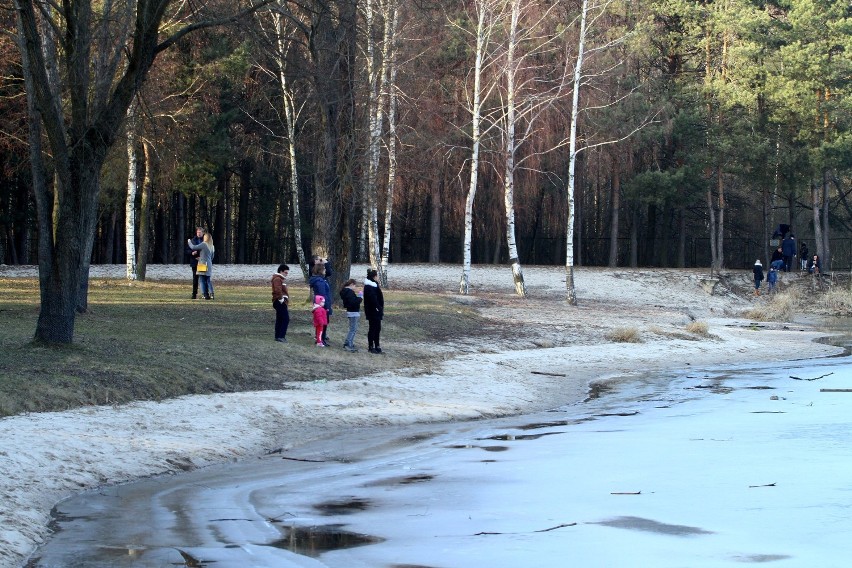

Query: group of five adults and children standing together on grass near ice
[[271, 256, 385, 354]]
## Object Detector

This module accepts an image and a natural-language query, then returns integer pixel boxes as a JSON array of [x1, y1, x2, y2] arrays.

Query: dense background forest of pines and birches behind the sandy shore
[[0, 0, 852, 278]]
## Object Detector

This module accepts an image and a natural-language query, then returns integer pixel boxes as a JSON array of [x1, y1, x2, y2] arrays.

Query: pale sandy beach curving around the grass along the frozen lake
[[0, 265, 838, 567]]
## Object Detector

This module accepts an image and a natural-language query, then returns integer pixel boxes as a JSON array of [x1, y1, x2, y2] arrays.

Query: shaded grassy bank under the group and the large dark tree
[[0, 278, 487, 416]]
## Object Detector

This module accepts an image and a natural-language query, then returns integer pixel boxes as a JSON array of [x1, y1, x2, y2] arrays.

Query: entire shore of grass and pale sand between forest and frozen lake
[[0, 265, 848, 566]]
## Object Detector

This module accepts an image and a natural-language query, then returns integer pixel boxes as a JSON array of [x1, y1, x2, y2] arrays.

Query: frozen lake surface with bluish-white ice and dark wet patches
[[29, 348, 852, 568]]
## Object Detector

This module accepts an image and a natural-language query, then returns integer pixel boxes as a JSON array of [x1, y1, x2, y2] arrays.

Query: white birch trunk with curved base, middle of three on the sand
[[503, 0, 527, 298]]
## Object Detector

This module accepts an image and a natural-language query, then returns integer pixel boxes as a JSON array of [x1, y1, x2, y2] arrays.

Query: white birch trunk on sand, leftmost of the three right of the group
[[459, 3, 487, 294]]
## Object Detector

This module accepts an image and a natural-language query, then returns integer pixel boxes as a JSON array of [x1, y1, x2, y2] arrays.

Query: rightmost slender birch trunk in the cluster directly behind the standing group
[[379, 0, 399, 288]]
